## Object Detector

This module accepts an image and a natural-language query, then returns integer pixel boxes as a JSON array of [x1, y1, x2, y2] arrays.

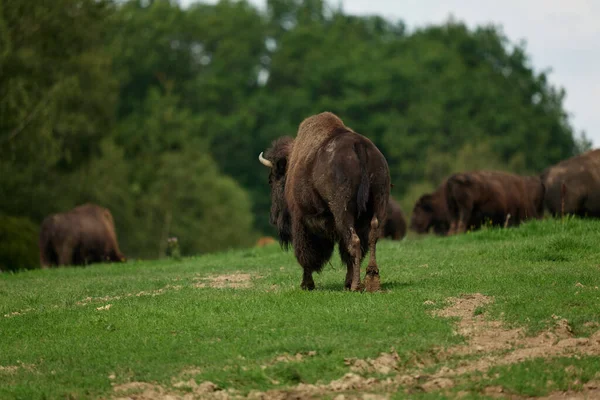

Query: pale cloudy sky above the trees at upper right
[[180, 0, 600, 147]]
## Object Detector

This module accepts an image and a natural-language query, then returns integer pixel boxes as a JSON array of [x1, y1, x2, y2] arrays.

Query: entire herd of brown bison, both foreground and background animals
[[39, 112, 600, 291]]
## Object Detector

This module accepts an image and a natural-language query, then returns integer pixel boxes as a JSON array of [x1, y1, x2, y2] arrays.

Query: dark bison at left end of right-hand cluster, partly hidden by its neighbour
[[410, 181, 450, 236]]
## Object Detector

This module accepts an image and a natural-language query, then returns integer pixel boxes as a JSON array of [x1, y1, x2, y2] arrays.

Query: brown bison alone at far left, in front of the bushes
[[39, 203, 126, 268]]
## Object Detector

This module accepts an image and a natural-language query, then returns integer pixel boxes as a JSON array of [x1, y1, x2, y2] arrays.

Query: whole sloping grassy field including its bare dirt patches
[[0, 219, 600, 399]]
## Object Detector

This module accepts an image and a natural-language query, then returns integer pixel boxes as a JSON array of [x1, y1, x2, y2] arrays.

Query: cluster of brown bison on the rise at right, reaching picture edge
[[410, 150, 600, 236]]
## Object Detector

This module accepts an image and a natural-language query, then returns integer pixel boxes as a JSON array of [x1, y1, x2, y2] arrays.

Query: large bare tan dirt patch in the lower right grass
[[338, 293, 600, 399]]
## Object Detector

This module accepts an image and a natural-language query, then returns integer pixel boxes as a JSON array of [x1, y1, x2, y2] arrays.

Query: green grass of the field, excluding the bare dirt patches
[[0, 219, 600, 399]]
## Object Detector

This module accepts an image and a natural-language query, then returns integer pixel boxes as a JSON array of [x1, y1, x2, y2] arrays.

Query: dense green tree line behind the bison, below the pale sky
[[0, 0, 590, 269]]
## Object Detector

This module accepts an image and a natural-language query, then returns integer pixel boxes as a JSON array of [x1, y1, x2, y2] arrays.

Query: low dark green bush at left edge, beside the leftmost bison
[[0, 214, 39, 271]]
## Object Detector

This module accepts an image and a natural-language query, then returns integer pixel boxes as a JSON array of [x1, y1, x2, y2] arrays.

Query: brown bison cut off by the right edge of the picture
[[541, 149, 600, 218]]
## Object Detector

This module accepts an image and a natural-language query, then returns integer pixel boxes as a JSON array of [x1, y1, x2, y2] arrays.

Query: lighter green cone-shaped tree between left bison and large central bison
[[117, 83, 254, 257]]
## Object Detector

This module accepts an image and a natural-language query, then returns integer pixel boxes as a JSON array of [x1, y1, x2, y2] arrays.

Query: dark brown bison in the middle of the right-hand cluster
[[446, 171, 544, 234]]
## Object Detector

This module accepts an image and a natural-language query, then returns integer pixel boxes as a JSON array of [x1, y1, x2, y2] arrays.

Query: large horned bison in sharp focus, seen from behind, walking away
[[259, 112, 390, 291]]
